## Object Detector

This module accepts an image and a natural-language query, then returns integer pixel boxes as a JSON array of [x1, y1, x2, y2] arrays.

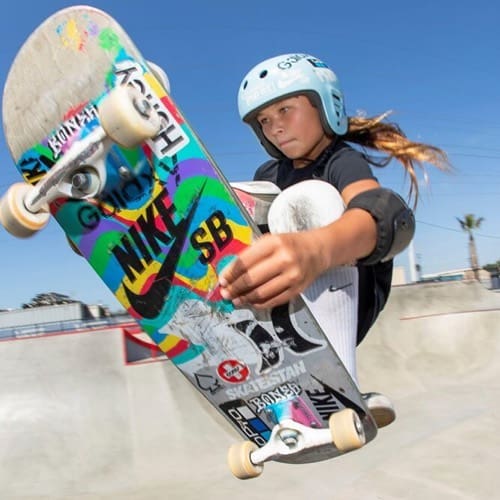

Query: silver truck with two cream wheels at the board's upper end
[[0, 86, 162, 238]]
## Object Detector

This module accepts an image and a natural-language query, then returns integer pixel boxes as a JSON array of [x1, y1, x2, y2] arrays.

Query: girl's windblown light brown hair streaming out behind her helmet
[[342, 112, 451, 207]]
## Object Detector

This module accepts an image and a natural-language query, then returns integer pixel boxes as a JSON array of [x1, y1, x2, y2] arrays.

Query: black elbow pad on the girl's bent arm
[[347, 188, 415, 266]]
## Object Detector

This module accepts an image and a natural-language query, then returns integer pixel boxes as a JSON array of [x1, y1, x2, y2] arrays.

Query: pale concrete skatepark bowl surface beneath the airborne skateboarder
[[0, 282, 500, 500]]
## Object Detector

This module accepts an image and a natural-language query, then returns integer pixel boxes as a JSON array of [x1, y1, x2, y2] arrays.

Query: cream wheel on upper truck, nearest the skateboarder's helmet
[[99, 85, 161, 148]]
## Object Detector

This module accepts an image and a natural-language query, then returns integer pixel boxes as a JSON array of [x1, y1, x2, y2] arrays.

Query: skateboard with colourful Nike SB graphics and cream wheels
[[0, 6, 377, 479]]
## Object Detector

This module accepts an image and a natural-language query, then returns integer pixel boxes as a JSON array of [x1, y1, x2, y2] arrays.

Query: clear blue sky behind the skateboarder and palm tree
[[0, 0, 500, 309]]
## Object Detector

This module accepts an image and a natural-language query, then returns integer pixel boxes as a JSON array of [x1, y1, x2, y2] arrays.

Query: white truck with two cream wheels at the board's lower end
[[227, 402, 366, 479]]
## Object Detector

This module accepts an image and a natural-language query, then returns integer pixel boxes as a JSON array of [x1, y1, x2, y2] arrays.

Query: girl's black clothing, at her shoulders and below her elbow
[[254, 140, 393, 344]]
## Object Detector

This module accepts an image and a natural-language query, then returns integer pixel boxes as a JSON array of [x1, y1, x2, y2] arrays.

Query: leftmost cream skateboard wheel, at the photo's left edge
[[0, 182, 50, 238]]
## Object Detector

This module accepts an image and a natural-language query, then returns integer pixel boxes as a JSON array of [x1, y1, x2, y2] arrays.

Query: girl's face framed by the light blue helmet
[[257, 95, 332, 168]]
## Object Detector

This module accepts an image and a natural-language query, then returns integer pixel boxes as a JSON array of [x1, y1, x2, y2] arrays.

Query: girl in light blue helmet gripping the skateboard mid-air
[[220, 54, 448, 427]]
